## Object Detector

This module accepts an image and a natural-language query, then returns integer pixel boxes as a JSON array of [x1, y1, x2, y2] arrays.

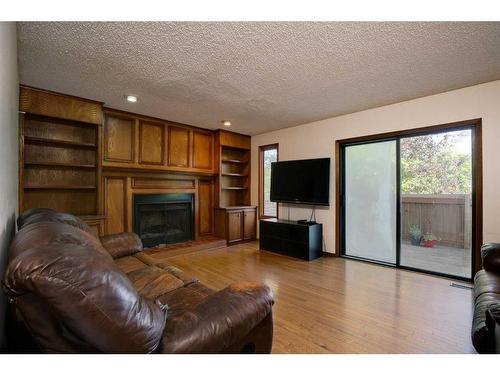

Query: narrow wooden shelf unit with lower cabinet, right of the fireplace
[[215, 130, 257, 244]]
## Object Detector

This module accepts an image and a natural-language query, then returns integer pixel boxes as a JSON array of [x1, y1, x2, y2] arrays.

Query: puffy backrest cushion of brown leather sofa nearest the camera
[[5, 242, 166, 353]]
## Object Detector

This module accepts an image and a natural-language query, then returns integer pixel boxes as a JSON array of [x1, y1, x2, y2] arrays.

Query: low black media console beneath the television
[[259, 219, 323, 260]]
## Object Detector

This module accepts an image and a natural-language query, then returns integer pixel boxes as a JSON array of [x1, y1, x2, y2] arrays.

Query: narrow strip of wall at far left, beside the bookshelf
[[0, 22, 19, 348]]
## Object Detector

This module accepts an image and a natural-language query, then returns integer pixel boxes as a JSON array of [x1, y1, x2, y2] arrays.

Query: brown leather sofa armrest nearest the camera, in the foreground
[[160, 282, 274, 353]]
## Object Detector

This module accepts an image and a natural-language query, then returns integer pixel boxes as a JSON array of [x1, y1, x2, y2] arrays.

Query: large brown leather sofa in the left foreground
[[3, 209, 274, 353]]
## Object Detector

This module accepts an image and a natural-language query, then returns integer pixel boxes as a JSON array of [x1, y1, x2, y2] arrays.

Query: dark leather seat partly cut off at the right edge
[[471, 243, 500, 353]]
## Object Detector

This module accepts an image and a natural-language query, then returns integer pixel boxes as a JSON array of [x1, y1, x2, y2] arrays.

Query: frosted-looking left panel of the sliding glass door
[[344, 140, 397, 264]]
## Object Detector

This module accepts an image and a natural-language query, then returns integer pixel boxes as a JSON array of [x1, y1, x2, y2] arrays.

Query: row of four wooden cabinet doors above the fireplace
[[103, 109, 214, 174]]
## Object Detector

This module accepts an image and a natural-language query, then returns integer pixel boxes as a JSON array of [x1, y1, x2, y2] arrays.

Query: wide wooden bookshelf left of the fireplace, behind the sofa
[[19, 87, 102, 220]]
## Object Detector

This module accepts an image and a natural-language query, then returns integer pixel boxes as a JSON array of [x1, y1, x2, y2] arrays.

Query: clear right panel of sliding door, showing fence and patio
[[400, 129, 472, 279]]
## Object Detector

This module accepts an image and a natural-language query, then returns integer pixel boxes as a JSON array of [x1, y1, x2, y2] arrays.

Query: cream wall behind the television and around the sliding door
[[251, 81, 500, 253]]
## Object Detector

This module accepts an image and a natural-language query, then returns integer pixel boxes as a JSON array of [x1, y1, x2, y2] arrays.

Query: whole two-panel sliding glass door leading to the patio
[[339, 125, 476, 279]]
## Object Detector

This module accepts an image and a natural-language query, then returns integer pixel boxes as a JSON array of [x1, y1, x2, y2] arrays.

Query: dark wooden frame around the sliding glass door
[[335, 118, 483, 281]]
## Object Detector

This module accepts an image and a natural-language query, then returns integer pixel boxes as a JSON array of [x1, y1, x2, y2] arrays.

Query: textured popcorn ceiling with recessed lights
[[18, 22, 500, 134]]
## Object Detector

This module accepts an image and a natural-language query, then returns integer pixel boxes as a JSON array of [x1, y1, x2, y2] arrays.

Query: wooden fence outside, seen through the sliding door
[[401, 194, 472, 249]]
